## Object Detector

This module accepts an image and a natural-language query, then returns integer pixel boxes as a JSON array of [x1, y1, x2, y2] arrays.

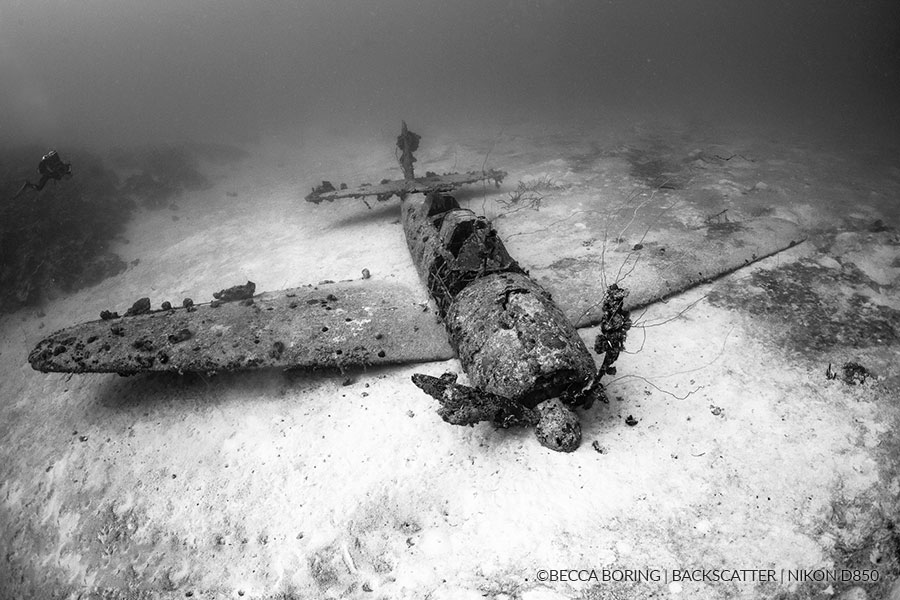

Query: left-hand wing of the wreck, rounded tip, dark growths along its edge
[[29, 280, 454, 374]]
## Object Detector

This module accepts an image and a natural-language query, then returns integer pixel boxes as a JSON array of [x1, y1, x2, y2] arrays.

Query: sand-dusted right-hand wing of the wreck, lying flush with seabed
[[510, 217, 805, 327]]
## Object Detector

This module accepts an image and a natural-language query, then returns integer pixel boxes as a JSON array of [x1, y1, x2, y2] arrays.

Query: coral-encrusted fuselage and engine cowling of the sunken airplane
[[402, 194, 596, 407]]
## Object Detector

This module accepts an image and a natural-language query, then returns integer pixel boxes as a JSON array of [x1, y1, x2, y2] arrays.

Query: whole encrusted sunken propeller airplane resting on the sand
[[29, 122, 799, 451]]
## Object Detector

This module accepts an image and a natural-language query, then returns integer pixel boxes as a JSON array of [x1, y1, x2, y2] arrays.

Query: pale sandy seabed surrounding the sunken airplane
[[0, 113, 900, 600]]
